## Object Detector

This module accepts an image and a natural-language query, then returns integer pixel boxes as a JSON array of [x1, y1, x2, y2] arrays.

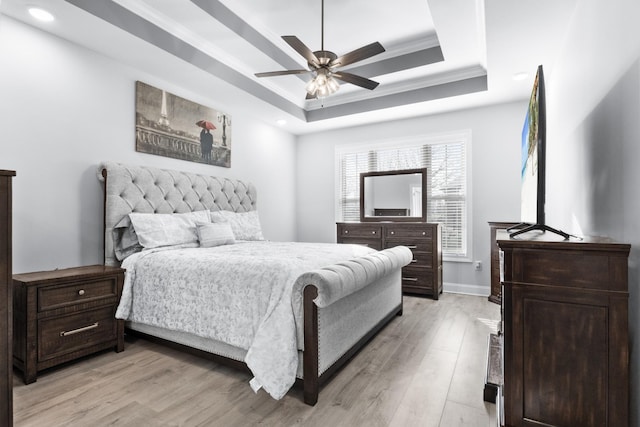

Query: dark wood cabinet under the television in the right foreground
[[497, 231, 630, 427]]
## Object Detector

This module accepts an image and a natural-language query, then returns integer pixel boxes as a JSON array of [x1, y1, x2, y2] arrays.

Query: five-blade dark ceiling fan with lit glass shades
[[255, 0, 384, 99]]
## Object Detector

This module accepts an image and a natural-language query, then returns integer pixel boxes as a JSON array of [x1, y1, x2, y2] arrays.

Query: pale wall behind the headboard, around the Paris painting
[[0, 16, 296, 273]]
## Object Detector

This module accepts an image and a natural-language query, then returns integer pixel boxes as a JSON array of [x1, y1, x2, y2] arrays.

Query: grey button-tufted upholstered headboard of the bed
[[98, 162, 257, 265]]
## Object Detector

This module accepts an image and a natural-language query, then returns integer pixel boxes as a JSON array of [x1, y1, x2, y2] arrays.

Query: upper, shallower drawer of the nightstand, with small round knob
[[38, 279, 118, 311]]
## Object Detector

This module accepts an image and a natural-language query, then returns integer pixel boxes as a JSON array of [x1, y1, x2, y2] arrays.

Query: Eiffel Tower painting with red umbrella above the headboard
[[136, 82, 231, 168]]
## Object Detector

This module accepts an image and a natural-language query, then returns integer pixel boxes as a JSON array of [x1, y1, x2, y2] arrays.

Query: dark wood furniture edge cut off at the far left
[[0, 170, 16, 426]]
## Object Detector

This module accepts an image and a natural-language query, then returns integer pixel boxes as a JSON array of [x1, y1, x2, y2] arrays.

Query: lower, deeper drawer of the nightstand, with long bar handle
[[38, 306, 116, 362]]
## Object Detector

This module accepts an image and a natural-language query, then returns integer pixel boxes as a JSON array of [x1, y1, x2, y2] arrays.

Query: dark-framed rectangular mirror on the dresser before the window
[[360, 168, 427, 222]]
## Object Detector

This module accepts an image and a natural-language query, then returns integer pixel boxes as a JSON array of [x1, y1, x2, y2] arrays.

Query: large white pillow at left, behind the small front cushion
[[129, 211, 211, 249]]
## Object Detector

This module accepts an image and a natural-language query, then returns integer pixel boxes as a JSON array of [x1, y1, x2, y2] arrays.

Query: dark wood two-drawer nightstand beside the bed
[[13, 265, 124, 384]]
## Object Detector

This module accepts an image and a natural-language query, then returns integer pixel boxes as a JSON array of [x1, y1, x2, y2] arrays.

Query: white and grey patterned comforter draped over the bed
[[116, 242, 374, 399]]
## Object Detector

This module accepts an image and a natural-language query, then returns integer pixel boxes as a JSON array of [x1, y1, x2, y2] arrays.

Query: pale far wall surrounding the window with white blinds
[[296, 100, 527, 295]]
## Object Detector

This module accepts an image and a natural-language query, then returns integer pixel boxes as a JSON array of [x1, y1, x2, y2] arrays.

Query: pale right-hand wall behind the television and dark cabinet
[[546, 0, 640, 426]]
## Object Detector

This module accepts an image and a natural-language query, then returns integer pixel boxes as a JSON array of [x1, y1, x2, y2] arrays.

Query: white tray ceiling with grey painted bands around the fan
[[0, 0, 577, 134]]
